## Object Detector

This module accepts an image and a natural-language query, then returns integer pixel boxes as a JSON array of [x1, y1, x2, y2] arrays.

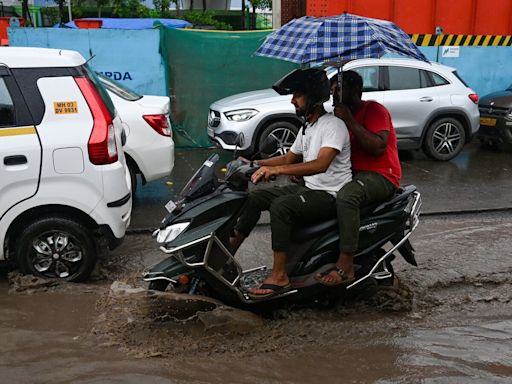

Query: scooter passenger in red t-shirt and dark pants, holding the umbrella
[[316, 71, 402, 286]]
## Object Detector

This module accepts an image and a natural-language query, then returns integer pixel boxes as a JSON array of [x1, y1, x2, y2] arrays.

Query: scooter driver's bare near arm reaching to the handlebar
[[251, 147, 338, 184]]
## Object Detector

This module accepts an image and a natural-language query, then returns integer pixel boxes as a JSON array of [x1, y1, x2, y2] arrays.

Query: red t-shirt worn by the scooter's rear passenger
[[350, 100, 402, 187]]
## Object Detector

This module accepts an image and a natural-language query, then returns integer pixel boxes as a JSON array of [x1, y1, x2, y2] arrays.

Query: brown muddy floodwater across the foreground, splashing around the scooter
[[0, 214, 512, 383]]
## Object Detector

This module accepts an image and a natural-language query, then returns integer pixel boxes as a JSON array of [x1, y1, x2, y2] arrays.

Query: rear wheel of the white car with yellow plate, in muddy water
[[15, 217, 97, 282]]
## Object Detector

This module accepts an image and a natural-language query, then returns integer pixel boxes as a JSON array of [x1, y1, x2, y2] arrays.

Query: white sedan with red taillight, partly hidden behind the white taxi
[[98, 73, 174, 195]]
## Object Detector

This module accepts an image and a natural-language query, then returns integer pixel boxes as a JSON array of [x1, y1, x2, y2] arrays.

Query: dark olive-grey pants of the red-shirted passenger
[[336, 172, 396, 253]]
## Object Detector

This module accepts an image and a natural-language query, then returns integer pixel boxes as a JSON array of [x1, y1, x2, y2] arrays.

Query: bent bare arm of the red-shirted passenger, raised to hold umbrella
[[334, 104, 388, 156]]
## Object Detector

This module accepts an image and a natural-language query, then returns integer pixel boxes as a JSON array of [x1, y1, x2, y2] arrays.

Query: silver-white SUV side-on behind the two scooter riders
[[207, 58, 480, 160]]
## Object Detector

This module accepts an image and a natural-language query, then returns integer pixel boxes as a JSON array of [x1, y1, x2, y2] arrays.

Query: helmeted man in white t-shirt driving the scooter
[[230, 69, 352, 299]]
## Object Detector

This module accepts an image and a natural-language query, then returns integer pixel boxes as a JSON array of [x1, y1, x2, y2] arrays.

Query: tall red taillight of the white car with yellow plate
[[75, 77, 118, 165]]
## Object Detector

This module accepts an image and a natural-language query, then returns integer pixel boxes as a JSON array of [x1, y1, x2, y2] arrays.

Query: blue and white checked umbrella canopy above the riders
[[256, 13, 428, 64]]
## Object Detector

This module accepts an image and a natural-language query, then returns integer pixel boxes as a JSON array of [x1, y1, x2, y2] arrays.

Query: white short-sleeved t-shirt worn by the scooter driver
[[290, 113, 352, 195]]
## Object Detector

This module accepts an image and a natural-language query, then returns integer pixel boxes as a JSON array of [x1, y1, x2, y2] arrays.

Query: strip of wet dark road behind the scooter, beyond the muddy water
[[131, 143, 512, 230]]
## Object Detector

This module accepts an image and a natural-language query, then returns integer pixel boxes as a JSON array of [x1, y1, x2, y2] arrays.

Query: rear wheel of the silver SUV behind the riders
[[423, 117, 466, 161]]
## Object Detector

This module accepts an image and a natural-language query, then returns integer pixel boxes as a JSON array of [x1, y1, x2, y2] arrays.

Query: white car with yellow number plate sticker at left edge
[[0, 47, 131, 281]]
